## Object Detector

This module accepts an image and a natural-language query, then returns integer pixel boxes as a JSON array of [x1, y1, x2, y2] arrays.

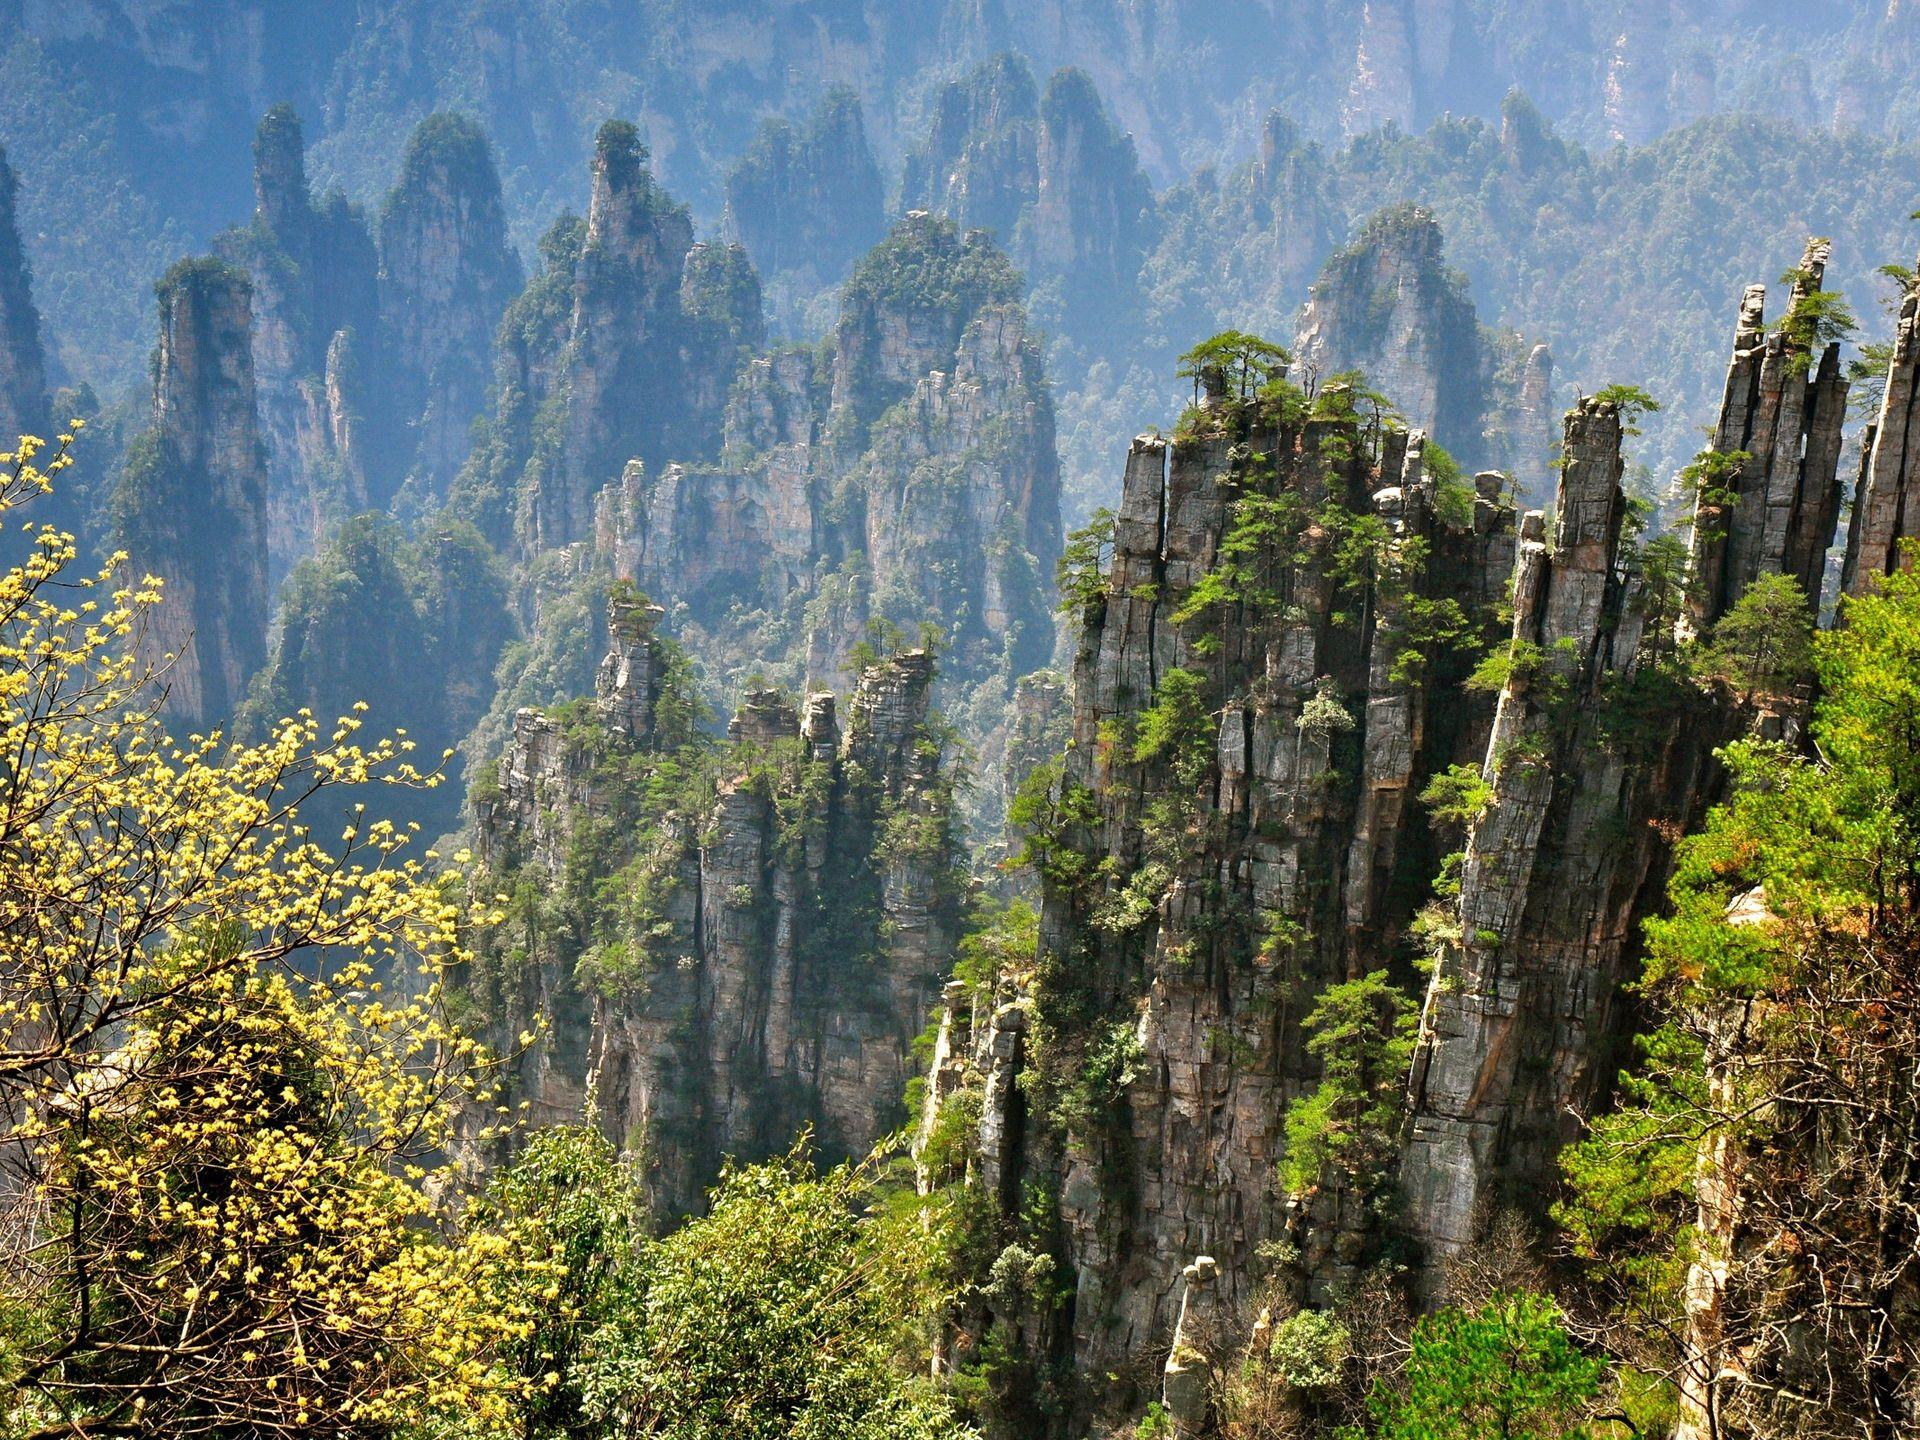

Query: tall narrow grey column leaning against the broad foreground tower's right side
[[1402, 399, 1638, 1254]]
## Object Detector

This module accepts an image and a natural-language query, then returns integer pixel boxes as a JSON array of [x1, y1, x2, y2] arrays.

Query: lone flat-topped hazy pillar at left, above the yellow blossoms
[[113, 259, 267, 724]]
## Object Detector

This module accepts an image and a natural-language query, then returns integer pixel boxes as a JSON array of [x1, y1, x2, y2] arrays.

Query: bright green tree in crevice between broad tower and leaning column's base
[[1281, 970, 1419, 1200]]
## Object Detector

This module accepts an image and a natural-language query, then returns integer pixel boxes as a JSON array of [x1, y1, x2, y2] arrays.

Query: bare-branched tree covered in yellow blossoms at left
[[0, 436, 511, 1436]]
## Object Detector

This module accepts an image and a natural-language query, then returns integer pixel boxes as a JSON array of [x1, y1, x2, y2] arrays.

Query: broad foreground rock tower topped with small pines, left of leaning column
[[913, 374, 1513, 1436]]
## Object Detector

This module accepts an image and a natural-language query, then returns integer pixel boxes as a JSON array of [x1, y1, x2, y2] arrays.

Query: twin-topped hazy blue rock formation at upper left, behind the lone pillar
[[215, 106, 520, 584]]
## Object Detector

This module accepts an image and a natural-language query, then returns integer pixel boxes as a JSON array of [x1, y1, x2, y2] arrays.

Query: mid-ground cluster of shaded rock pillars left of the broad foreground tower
[[476, 625, 960, 1215]]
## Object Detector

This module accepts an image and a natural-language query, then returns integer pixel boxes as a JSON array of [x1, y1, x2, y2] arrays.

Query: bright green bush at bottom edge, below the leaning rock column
[[1367, 1292, 1605, 1440]]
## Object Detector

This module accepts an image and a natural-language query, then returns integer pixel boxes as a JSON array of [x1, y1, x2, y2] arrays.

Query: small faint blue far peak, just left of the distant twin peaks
[[726, 86, 885, 288]]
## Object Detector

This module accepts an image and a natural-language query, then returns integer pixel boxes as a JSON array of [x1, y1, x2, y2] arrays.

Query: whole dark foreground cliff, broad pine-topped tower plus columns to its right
[[922, 250, 1858, 1434]]
